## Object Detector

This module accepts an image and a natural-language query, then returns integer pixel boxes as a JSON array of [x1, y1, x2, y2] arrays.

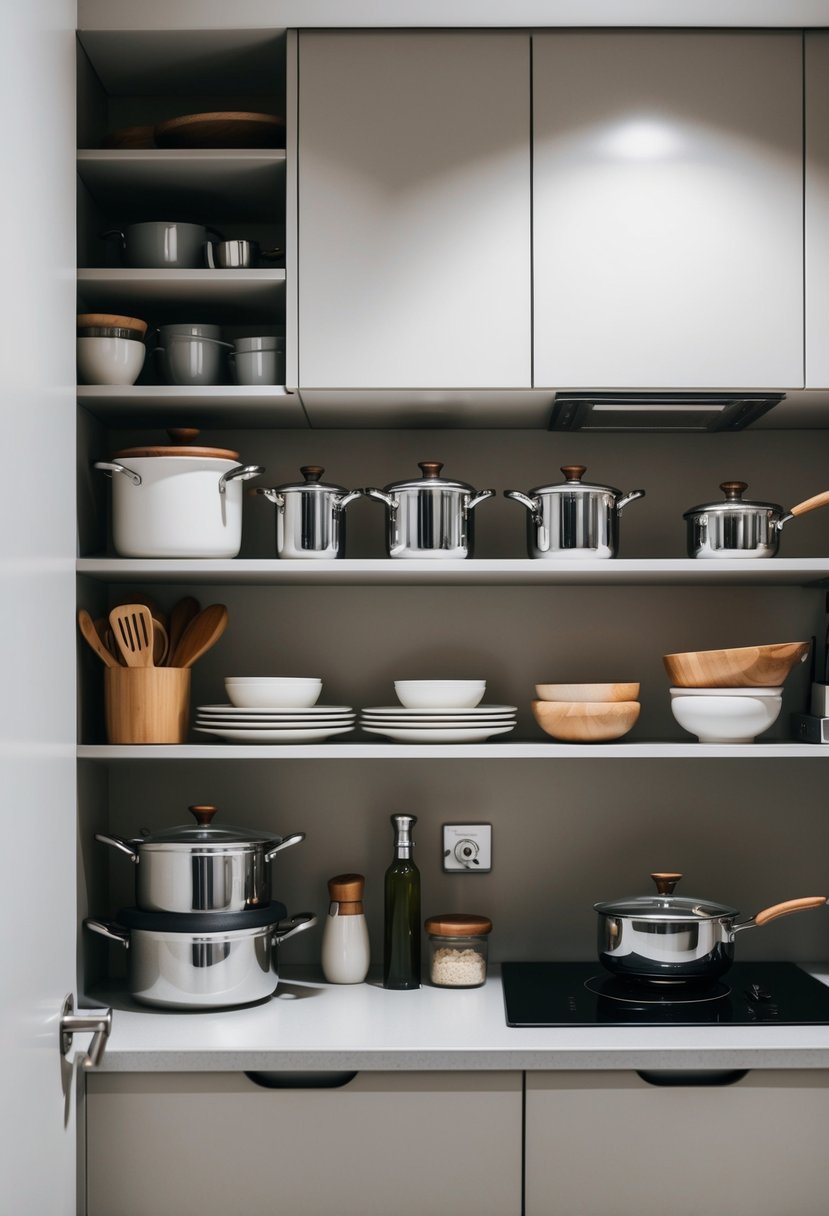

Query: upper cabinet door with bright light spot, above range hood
[[532, 30, 803, 389]]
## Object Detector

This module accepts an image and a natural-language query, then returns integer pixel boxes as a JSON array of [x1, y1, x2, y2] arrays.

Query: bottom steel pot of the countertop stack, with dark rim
[[84, 903, 317, 1009]]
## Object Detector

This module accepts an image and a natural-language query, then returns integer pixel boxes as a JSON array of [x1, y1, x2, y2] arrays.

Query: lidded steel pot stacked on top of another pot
[[95, 806, 305, 916]]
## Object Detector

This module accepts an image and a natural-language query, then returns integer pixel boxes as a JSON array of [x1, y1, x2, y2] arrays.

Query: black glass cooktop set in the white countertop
[[501, 963, 829, 1026]]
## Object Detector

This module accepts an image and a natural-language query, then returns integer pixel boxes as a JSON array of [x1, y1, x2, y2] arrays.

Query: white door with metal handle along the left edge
[[0, 0, 80, 1216]]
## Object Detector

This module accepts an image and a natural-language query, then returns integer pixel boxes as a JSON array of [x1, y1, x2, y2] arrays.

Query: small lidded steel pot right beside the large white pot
[[256, 465, 363, 559]]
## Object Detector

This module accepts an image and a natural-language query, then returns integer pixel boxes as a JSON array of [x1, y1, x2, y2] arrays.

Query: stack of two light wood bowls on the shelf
[[532, 683, 641, 743]]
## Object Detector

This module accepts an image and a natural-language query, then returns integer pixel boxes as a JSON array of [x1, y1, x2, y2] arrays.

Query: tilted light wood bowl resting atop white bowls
[[662, 642, 811, 688]]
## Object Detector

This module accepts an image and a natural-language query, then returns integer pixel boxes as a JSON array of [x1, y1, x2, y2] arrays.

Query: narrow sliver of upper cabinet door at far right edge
[[805, 30, 829, 388]]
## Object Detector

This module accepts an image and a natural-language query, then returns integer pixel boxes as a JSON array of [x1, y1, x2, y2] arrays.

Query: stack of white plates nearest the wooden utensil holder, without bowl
[[194, 705, 357, 743]]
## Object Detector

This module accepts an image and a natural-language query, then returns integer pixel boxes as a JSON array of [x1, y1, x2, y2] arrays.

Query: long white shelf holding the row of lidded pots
[[77, 556, 829, 587]]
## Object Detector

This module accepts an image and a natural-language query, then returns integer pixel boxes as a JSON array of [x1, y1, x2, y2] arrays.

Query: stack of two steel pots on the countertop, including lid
[[84, 806, 316, 1009]]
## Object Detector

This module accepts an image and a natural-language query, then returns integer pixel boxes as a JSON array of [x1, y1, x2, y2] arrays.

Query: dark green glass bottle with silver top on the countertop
[[383, 815, 421, 989]]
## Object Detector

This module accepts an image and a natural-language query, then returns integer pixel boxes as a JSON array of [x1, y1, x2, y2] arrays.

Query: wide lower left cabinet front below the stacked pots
[[86, 1073, 523, 1216]]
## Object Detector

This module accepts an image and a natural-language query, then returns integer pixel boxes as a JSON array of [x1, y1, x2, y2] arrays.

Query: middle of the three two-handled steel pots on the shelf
[[363, 461, 495, 559]]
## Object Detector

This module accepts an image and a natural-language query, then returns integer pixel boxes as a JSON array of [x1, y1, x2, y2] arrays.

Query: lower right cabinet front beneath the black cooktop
[[525, 1070, 829, 1216]]
